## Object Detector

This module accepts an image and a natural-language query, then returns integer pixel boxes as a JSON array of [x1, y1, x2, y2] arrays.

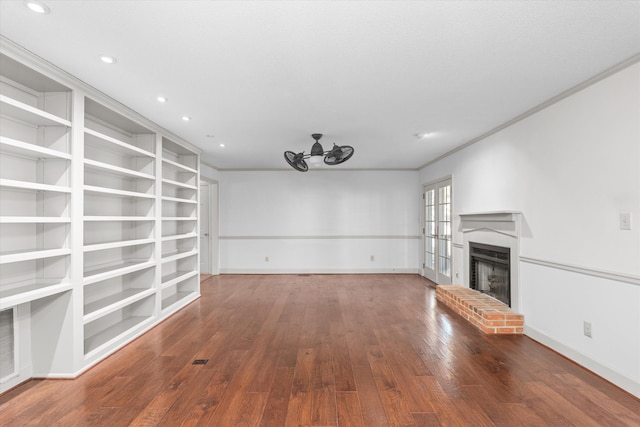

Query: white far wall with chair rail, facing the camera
[[219, 170, 420, 273]]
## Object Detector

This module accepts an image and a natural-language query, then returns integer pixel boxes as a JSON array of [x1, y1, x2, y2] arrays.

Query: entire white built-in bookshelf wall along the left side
[[0, 39, 200, 391]]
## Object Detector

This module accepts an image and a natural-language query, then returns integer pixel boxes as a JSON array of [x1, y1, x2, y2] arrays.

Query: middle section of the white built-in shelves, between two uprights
[[83, 98, 156, 356]]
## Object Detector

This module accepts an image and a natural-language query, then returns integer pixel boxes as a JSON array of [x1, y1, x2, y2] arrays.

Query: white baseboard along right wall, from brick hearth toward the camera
[[524, 325, 640, 398]]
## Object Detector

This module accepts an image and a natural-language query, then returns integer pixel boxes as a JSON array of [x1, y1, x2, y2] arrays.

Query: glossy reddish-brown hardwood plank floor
[[0, 275, 640, 427]]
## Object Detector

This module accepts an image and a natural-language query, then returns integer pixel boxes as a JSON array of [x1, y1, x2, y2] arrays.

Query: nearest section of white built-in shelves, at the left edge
[[0, 54, 72, 391]]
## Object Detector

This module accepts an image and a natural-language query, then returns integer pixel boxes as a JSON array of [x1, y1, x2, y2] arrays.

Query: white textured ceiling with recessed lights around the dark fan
[[0, 0, 640, 169]]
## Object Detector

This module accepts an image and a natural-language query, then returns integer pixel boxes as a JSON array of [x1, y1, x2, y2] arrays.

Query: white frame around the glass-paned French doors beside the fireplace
[[420, 175, 454, 285]]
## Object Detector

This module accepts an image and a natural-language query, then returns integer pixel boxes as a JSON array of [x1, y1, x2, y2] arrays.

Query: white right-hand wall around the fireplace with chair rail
[[420, 64, 640, 396]]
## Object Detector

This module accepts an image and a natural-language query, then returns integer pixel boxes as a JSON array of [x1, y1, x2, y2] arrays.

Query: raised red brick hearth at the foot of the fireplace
[[436, 285, 524, 335]]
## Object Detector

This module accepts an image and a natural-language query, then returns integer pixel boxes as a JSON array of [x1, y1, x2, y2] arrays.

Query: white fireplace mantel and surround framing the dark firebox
[[458, 210, 522, 313]]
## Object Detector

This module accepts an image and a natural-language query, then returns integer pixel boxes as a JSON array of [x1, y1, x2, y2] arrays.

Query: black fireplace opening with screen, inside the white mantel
[[469, 242, 511, 307]]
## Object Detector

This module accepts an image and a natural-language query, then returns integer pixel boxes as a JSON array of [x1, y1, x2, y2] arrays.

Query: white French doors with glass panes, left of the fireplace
[[423, 179, 452, 285]]
